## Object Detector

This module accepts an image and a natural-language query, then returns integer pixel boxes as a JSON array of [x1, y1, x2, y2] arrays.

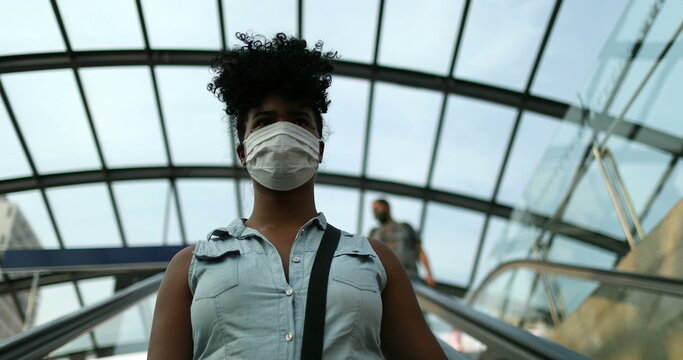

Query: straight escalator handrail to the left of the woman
[[0, 273, 163, 360]]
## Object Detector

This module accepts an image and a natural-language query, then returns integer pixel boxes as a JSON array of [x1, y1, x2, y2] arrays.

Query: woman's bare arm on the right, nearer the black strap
[[370, 240, 446, 359]]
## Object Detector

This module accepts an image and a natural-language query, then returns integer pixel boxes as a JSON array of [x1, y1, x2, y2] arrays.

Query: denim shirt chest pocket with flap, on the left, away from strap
[[194, 244, 240, 300]]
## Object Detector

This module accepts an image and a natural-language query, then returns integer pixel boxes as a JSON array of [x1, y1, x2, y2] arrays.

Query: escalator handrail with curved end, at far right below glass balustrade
[[466, 260, 683, 305]]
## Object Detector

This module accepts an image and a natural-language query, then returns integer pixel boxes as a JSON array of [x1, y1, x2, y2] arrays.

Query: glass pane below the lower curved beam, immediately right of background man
[[422, 203, 484, 286]]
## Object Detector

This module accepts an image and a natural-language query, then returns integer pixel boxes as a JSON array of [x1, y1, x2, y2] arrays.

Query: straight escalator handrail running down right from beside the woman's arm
[[413, 282, 588, 360]]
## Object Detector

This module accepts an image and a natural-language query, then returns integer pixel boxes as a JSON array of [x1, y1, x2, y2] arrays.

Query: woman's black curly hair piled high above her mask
[[207, 33, 337, 143]]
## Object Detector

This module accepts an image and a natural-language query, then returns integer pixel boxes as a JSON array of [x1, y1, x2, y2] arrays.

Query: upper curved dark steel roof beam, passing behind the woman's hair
[[0, 50, 683, 156]]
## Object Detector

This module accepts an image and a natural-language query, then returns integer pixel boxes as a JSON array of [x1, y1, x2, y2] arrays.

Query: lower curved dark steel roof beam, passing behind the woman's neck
[[0, 166, 628, 256]]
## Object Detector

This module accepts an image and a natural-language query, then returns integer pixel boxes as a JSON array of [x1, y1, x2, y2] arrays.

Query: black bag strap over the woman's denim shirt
[[301, 224, 341, 360]]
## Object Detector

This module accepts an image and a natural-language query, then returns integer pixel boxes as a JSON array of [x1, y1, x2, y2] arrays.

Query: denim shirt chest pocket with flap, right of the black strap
[[331, 249, 379, 292]]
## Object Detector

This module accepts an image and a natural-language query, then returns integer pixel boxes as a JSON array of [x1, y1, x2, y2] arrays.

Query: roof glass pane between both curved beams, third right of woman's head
[[432, 96, 516, 198]]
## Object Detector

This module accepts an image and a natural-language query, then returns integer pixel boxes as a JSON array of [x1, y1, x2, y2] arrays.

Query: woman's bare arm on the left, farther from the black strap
[[147, 245, 194, 360]]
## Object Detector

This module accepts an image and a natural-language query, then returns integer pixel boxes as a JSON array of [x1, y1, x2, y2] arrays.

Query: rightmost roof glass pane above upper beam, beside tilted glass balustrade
[[532, 0, 628, 102]]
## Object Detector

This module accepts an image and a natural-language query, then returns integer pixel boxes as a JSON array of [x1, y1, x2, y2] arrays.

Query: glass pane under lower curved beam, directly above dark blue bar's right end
[[113, 180, 182, 246]]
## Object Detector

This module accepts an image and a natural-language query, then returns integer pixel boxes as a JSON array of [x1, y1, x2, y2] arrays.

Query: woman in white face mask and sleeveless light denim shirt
[[148, 33, 444, 359]]
